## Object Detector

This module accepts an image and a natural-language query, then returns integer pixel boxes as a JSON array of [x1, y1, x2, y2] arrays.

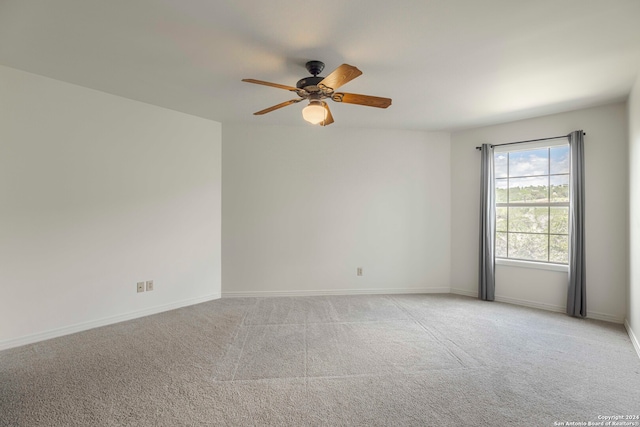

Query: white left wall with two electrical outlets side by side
[[0, 67, 221, 349]]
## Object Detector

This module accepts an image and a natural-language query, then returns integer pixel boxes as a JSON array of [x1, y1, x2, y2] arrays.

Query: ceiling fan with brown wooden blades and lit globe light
[[242, 61, 391, 126]]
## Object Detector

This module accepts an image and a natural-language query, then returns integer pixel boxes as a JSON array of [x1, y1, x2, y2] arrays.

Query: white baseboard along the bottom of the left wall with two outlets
[[0, 293, 220, 351]]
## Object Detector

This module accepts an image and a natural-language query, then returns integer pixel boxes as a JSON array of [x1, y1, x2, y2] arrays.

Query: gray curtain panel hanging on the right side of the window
[[567, 130, 587, 317]]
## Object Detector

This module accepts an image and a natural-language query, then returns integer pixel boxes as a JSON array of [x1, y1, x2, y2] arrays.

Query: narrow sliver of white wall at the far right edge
[[626, 75, 640, 356]]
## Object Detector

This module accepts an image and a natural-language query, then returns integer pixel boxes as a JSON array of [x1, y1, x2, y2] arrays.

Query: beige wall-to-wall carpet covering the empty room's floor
[[0, 295, 640, 426]]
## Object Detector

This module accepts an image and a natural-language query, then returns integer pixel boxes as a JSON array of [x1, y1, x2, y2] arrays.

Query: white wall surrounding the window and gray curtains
[[451, 103, 628, 323]]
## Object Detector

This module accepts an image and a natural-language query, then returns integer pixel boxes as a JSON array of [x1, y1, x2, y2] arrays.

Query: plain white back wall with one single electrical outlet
[[222, 124, 450, 295]]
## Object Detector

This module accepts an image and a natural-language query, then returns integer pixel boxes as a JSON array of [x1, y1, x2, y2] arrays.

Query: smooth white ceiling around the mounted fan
[[0, 0, 640, 130]]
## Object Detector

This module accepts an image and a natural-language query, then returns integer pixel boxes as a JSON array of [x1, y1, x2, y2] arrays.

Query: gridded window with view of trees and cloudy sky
[[494, 140, 570, 264]]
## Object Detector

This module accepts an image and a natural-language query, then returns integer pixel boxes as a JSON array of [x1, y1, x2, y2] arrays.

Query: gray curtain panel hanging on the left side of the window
[[478, 144, 496, 301]]
